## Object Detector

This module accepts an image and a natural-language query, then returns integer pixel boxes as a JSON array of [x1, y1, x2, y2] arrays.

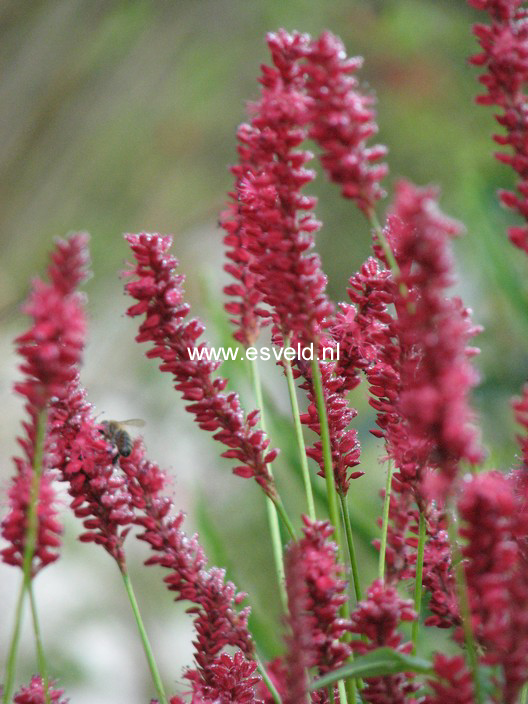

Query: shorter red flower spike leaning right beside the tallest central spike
[[305, 32, 388, 216]]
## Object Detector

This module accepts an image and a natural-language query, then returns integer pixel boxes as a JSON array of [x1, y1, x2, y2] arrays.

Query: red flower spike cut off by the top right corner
[[469, 0, 528, 253]]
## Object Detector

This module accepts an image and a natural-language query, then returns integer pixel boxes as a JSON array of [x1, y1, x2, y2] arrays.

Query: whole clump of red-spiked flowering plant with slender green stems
[[0, 6, 528, 704]]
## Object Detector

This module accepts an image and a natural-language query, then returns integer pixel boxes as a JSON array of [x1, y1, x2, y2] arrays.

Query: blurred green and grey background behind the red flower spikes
[[0, 0, 528, 704]]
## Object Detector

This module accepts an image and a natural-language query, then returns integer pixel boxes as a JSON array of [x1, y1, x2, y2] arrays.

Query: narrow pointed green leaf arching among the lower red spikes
[[310, 648, 433, 692]]
